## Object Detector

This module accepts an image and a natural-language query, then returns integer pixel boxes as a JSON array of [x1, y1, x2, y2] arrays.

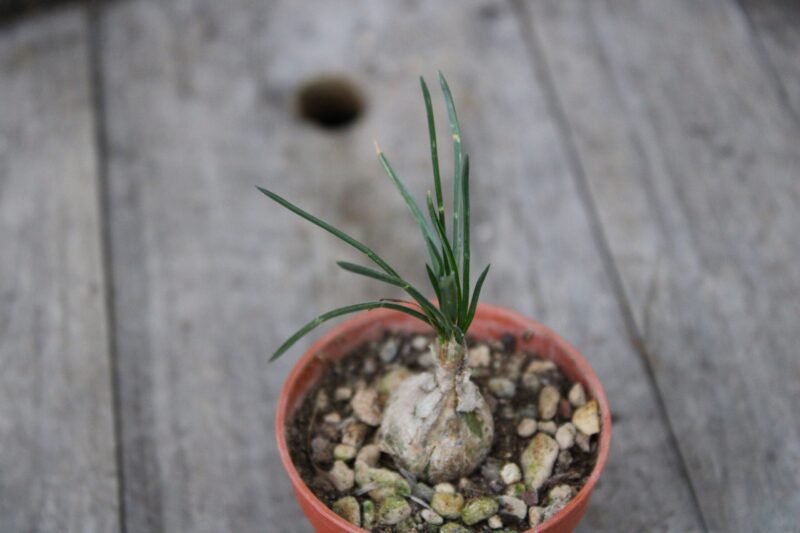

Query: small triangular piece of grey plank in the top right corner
[[739, 0, 800, 121]]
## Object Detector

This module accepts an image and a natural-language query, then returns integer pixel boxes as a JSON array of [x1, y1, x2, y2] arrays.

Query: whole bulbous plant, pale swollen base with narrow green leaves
[[259, 73, 494, 483]]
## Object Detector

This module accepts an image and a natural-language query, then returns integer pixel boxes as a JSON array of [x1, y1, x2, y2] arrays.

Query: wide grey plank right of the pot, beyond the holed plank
[[528, 0, 800, 531]]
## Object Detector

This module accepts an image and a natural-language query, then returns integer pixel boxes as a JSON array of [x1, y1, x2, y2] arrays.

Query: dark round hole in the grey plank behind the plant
[[297, 76, 365, 129]]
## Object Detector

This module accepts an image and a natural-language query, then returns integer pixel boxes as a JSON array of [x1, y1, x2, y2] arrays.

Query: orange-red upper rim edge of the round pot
[[275, 303, 611, 533]]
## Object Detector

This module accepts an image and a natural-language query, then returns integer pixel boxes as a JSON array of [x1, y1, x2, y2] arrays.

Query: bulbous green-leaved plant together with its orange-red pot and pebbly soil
[[259, 74, 611, 533]]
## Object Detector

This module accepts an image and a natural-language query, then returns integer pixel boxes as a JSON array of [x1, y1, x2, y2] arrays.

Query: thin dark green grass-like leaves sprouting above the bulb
[[258, 72, 489, 360]]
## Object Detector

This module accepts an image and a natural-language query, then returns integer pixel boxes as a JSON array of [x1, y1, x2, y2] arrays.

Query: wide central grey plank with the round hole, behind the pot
[[101, 0, 699, 531]]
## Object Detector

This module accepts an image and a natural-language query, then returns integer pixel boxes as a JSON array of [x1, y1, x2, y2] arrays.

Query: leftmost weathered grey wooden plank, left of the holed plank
[[0, 8, 119, 532]]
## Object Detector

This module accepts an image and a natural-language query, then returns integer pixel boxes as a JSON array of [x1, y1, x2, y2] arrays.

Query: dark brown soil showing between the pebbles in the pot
[[287, 331, 597, 533]]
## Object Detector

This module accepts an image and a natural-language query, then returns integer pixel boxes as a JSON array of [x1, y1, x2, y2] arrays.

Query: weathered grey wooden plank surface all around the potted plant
[[0, 0, 800, 532]]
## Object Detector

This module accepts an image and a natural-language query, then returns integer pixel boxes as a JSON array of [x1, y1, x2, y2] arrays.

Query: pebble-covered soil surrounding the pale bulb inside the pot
[[287, 331, 600, 533]]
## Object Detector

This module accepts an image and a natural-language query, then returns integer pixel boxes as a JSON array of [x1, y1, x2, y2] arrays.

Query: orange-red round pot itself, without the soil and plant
[[275, 304, 611, 533]]
